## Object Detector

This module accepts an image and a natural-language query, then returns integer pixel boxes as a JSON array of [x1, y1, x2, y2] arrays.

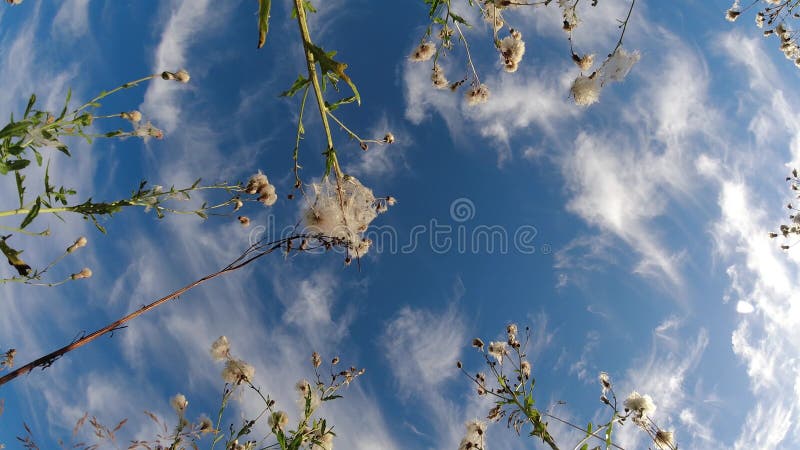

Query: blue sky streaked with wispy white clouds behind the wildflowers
[[0, 0, 800, 449]]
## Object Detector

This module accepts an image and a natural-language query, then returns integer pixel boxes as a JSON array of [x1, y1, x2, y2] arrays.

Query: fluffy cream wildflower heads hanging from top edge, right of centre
[[409, 0, 640, 106]]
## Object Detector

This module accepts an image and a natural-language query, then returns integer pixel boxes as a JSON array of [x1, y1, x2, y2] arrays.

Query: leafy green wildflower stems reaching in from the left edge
[[0, 69, 270, 286]]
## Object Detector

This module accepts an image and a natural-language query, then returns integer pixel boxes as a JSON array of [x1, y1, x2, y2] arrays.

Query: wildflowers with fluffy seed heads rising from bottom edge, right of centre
[[457, 324, 677, 450]]
